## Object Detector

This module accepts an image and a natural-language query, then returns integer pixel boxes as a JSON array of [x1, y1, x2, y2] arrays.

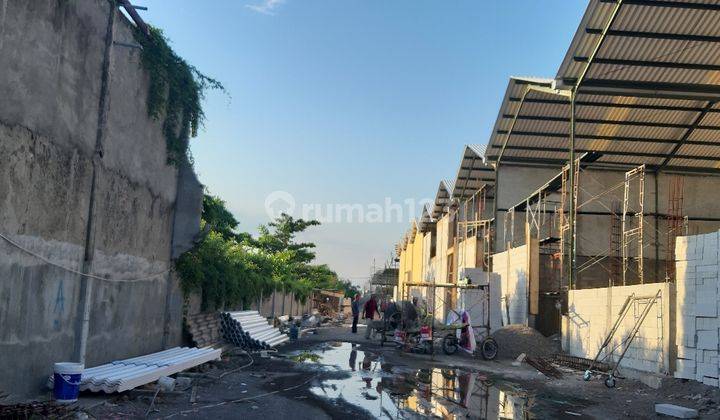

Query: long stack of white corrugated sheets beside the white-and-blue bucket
[[51, 347, 221, 393]]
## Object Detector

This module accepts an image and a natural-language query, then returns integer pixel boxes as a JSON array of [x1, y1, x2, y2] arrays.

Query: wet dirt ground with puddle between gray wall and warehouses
[[81, 328, 720, 419]]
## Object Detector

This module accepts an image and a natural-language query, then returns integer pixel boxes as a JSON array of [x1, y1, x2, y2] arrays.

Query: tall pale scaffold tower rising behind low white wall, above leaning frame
[[621, 165, 645, 286]]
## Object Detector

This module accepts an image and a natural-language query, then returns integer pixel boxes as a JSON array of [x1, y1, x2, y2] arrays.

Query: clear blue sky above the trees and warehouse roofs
[[135, 0, 587, 281]]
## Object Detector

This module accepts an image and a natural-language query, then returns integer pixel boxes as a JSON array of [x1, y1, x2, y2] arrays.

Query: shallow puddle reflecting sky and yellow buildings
[[296, 343, 532, 419]]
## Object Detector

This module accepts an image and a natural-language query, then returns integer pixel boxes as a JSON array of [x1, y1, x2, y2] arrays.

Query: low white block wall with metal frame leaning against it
[[562, 283, 675, 374]]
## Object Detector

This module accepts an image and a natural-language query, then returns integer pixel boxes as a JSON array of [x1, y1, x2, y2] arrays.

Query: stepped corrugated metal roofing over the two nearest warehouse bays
[[486, 0, 720, 171]]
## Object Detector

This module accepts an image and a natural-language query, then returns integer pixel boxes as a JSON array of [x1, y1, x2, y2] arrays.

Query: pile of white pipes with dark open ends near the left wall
[[220, 311, 290, 350]]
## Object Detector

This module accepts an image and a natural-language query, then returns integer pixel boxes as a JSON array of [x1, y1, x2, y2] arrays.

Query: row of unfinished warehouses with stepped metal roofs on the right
[[395, 0, 720, 386]]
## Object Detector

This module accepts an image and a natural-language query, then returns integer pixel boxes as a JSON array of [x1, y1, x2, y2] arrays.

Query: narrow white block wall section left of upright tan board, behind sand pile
[[492, 245, 529, 325]]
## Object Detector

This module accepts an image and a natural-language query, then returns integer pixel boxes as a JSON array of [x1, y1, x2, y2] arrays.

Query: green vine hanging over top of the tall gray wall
[[135, 26, 226, 165]]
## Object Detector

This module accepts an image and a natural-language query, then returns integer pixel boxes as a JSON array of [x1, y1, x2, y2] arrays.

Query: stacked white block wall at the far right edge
[[675, 232, 720, 386]]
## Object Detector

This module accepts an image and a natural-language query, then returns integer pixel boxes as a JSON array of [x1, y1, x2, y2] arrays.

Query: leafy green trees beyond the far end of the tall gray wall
[[176, 199, 344, 310]]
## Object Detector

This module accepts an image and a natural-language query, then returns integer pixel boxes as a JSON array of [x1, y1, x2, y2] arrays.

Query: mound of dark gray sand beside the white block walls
[[492, 324, 559, 359]]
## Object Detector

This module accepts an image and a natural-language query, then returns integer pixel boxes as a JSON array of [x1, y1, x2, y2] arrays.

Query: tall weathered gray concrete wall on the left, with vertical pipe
[[0, 0, 197, 396]]
